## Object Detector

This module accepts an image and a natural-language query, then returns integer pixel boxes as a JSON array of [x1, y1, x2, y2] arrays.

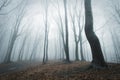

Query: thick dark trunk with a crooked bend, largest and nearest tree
[[85, 0, 107, 67]]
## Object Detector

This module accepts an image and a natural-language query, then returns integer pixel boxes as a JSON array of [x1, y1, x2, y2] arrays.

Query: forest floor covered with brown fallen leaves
[[0, 61, 120, 80]]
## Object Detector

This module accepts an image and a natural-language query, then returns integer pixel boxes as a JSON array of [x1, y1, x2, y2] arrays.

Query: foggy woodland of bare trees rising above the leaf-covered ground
[[0, 0, 120, 76]]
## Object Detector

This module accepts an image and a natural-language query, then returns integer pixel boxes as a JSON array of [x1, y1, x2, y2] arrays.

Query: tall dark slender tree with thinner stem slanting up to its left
[[56, 0, 70, 62]]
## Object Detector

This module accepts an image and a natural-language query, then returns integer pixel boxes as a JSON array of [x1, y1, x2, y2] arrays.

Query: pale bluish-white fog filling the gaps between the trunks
[[0, 0, 120, 63]]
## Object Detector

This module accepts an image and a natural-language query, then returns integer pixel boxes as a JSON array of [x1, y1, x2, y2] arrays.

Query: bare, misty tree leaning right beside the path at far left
[[4, 2, 26, 63]]
